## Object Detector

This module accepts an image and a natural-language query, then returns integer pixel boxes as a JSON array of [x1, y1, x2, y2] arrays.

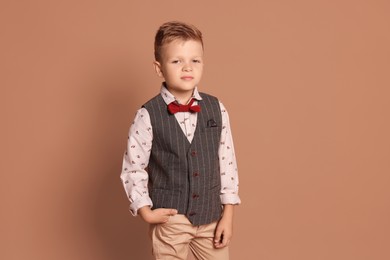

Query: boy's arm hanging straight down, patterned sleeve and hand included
[[214, 103, 241, 248]]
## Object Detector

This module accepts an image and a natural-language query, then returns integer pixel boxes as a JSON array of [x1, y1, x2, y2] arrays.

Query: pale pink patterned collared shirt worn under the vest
[[120, 85, 241, 216]]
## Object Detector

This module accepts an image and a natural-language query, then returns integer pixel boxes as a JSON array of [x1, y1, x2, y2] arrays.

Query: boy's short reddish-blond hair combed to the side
[[154, 21, 203, 61]]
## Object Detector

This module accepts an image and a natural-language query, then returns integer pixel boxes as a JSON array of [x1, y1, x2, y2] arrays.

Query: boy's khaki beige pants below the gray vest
[[150, 214, 229, 260]]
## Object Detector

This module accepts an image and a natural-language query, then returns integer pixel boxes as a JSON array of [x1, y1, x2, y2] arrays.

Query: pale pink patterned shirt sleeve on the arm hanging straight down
[[218, 103, 241, 205]]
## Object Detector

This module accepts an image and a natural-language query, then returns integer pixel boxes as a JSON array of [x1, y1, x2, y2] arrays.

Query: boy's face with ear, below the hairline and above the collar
[[154, 40, 203, 100]]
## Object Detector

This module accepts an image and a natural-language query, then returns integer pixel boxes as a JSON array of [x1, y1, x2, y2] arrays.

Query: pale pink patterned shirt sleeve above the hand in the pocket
[[120, 108, 153, 216]]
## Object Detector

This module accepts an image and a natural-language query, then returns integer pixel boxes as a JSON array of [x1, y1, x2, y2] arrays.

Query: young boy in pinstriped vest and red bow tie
[[121, 22, 240, 260]]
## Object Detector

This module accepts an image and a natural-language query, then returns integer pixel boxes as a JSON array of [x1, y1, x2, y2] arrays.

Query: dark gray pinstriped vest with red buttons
[[143, 93, 222, 226]]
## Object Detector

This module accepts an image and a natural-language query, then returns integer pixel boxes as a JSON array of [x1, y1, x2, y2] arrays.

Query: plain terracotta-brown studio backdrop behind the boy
[[0, 0, 390, 260]]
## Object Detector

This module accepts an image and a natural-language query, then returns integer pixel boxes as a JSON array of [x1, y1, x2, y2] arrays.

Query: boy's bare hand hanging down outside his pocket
[[214, 205, 234, 248]]
